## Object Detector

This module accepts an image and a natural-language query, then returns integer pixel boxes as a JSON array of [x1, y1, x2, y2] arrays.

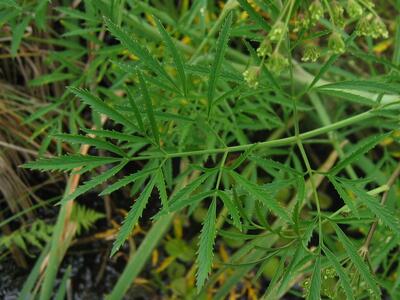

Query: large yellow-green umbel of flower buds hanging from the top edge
[[243, 0, 389, 87]]
